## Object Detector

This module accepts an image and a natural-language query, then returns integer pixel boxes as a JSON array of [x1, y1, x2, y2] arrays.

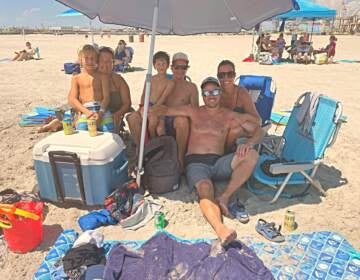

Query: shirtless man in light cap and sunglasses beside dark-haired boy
[[127, 52, 199, 170]]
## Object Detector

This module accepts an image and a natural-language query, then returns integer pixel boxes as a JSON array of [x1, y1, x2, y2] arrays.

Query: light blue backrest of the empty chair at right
[[281, 94, 342, 162]]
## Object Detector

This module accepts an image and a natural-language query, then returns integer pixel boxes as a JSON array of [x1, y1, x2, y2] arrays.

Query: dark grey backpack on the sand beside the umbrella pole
[[143, 136, 180, 194]]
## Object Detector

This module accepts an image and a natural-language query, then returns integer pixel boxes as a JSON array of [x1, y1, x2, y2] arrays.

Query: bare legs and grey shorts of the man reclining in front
[[186, 145, 258, 244]]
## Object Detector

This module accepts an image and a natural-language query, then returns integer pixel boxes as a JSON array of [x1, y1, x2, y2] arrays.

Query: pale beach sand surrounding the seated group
[[0, 35, 360, 279]]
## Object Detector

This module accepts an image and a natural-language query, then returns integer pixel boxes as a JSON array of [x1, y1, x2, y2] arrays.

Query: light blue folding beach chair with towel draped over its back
[[248, 93, 343, 203]]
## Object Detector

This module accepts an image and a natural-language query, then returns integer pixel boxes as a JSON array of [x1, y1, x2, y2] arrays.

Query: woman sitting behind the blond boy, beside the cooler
[[98, 47, 131, 133]]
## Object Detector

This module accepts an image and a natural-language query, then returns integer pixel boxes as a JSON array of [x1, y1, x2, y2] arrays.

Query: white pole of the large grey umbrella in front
[[136, 0, 159, 186]]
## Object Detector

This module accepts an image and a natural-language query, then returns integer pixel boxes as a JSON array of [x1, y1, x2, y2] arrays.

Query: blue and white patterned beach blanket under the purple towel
[[33, 230, 360, 280]]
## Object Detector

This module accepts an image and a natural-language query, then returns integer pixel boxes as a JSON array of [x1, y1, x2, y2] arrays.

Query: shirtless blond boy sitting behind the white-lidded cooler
[[68, 45, 114, 131]]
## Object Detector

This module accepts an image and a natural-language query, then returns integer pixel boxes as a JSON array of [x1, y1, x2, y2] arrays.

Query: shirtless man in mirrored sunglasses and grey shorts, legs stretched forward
[[151, 77, 262, 244]]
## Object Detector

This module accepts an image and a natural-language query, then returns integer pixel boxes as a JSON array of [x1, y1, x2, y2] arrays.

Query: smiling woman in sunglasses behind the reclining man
[[217, 60, 261, 149]]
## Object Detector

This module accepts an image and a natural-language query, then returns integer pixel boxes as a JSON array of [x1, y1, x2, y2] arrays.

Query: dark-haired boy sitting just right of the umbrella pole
[[139, 51, 175, 138]]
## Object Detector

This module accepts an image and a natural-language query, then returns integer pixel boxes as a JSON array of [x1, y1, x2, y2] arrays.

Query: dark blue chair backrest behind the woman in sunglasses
[[239, 75, 276, 126]]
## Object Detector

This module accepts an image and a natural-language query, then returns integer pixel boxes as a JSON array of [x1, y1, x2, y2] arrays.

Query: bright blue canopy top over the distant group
[[276, 0, 336, 19]]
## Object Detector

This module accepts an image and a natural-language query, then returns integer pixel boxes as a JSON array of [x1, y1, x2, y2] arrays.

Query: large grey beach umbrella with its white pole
[[56, 0, 295, 184]]
